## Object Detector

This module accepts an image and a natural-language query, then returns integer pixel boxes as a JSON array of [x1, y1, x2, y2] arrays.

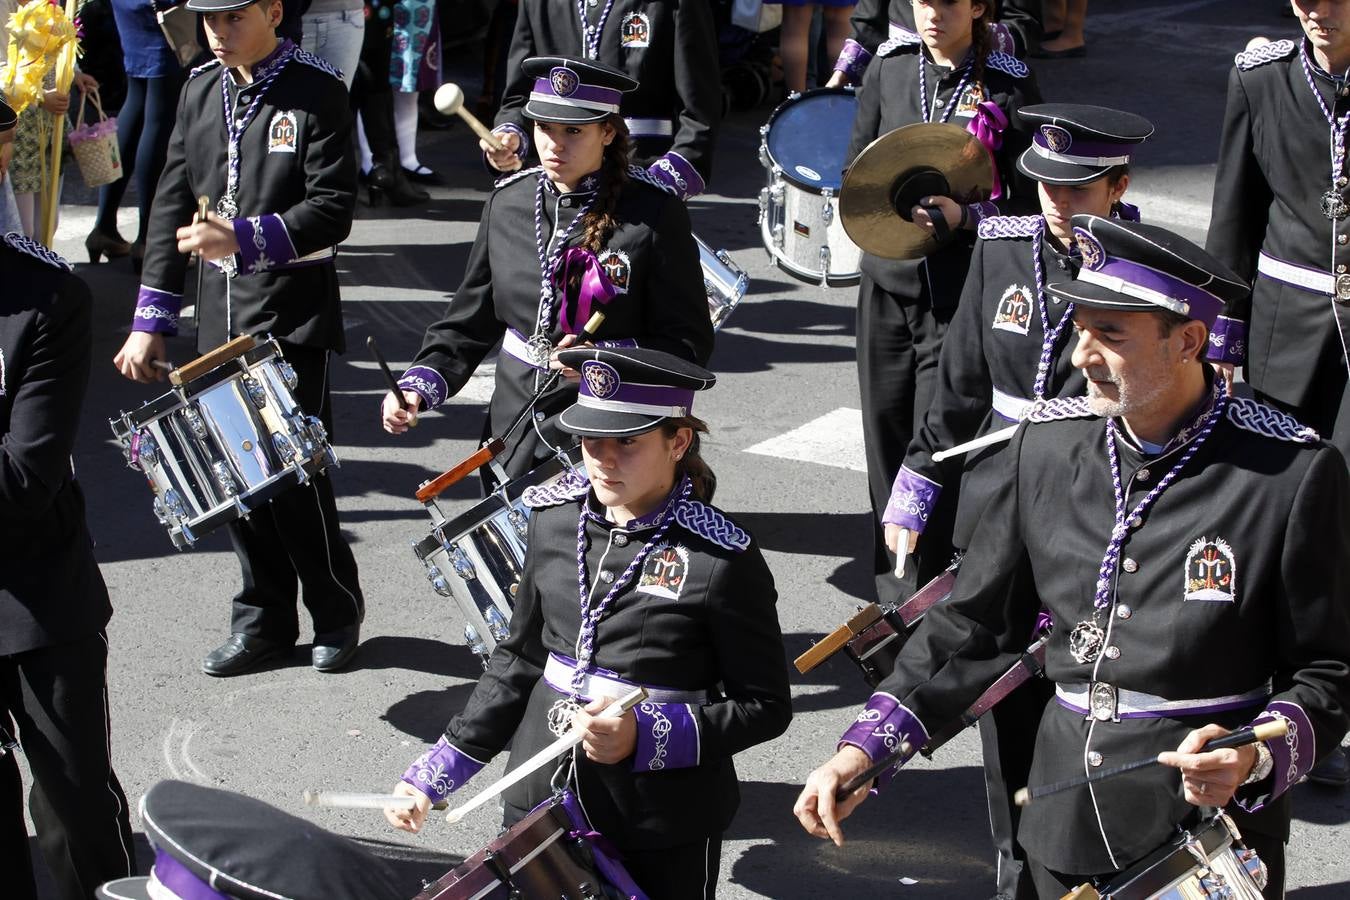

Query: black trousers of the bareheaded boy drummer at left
[[228, 344, 365, 644]]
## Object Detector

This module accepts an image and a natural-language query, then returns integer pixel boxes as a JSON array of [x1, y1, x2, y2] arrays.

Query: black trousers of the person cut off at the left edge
[[0, 633, 136, 900]]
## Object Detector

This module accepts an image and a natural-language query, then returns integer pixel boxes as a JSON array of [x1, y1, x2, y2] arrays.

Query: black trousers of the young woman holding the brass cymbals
[[857, 275, 957, 603]]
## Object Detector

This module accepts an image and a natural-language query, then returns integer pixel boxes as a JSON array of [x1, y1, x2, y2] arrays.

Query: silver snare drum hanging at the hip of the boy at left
[[108, 336, 338, 549]]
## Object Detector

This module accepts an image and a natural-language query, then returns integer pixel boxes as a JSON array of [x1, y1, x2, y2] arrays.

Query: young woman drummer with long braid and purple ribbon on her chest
[[382, 57, 713, 478]]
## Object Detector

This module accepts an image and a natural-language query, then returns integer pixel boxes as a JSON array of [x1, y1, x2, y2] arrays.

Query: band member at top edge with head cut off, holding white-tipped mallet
[[481, 0, 722, 198]]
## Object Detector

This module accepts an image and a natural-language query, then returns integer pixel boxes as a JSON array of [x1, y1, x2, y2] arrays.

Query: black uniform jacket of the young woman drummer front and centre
[[446, 488, 791, 849]]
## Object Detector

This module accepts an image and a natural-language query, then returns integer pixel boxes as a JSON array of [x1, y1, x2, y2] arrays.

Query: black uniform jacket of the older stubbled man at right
[[872, 399, 1350, 873]]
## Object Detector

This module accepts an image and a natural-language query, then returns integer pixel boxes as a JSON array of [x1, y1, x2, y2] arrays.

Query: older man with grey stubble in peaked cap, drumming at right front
[[795, 216, 1350, 897]]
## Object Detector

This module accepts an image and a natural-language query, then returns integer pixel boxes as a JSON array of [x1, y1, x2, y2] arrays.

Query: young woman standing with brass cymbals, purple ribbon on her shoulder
[[849, 0, 1040, 612]]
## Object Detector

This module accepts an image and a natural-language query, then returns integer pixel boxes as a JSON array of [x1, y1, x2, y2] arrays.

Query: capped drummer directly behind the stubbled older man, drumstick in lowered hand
[[883, 104, 1153, 897]]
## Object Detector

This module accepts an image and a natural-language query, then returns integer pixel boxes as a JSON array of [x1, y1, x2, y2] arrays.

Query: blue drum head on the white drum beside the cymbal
[[764, 88, 857, 193]]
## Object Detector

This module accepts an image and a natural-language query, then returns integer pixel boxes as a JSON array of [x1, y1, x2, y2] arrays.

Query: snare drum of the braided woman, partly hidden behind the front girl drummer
[[413, 449, 581, 667]]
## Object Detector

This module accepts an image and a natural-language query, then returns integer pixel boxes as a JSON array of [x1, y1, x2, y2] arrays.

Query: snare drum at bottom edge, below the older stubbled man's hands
[[1090, 812, 1266, 900]]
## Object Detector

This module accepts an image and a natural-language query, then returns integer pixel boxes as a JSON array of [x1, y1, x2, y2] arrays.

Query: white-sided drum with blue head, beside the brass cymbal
[[759, 88, 863, 285]]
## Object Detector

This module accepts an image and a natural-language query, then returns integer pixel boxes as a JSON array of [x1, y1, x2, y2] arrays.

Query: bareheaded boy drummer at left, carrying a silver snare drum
[[113, 0, 365, 676]]
